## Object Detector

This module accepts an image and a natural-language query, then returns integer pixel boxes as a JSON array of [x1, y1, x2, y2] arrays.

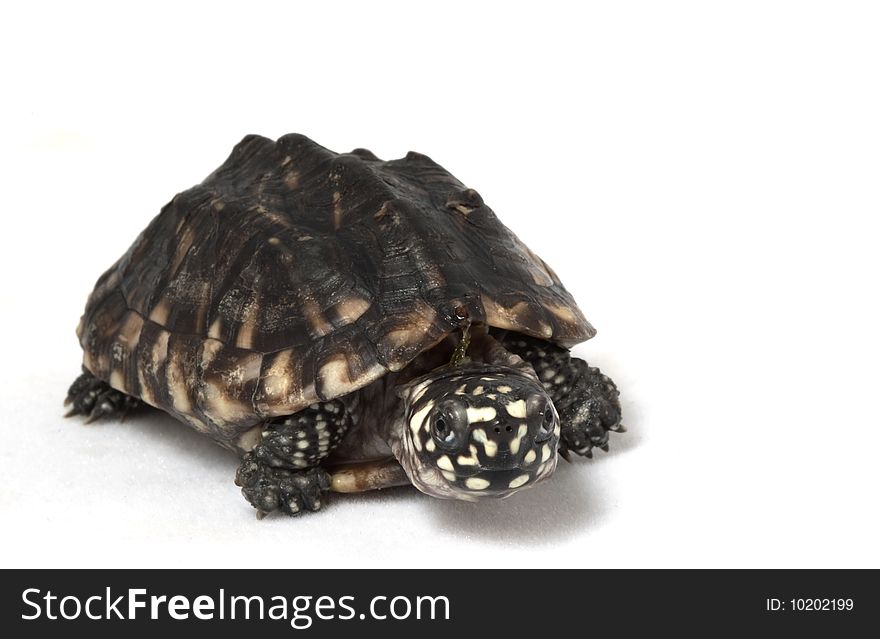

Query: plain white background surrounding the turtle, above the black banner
[[0, 1, 880, 567]]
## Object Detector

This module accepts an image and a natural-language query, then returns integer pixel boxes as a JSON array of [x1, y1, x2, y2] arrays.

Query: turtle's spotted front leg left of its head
[[235, 400, 351, 519]]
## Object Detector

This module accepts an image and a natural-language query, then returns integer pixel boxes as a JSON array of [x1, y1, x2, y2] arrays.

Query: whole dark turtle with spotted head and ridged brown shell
[[66, 134, 624, 517]]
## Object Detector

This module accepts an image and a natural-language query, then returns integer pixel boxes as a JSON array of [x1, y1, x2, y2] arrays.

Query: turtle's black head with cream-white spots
[[394, 364, 559, 501]]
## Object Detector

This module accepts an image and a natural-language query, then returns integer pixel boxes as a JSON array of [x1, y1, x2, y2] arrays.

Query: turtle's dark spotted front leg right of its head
[[501, 333, 625, 458]]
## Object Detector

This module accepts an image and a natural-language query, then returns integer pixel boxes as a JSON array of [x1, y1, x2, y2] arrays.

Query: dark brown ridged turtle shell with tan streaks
[[78, 135, 595, 443]]
